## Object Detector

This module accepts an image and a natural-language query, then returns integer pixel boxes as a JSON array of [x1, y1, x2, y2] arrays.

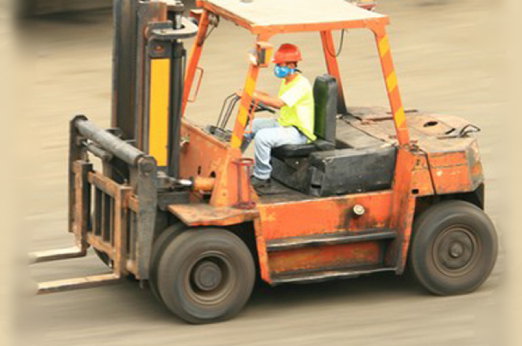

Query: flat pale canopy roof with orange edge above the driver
[[198, 0, 388, 34]]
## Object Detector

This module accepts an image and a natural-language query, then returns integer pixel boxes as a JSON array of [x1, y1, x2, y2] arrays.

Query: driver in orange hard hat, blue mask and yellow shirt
[[245, 43, 316, 190]]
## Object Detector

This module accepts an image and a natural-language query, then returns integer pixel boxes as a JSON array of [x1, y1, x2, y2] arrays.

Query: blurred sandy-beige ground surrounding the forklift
[[0, 0, 521, 346]]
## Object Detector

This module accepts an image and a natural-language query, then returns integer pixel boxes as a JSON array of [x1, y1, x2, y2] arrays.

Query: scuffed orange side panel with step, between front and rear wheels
[[254, 191, 392, 283]]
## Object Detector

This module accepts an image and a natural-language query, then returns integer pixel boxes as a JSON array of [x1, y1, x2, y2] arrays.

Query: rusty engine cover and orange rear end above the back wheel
[[344, 108, 484, 196]]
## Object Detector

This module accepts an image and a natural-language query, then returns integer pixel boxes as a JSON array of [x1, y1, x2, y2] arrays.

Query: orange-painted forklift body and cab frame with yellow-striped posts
[[169, 1, 482, 282]]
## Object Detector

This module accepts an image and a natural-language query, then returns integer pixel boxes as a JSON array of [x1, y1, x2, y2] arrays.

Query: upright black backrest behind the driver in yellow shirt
[[314, 74, 337, 143]]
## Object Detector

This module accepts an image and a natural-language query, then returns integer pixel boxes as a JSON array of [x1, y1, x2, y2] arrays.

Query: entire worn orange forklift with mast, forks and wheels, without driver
[[32, 0, 497, 323]]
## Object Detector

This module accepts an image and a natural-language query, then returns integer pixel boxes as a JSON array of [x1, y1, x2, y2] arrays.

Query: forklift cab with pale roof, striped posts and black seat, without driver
[[179, 0, 402, 197]]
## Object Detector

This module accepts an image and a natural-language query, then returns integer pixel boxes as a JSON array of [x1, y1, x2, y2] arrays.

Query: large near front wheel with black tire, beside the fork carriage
[[157, 229, 255, 324]]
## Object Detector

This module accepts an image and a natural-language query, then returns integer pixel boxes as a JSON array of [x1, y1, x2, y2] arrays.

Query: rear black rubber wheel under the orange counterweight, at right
[[409, 200, 498, 295]]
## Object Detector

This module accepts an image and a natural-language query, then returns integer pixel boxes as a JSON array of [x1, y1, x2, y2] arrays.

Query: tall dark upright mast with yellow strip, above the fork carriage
[[111, 0, 192, 178]]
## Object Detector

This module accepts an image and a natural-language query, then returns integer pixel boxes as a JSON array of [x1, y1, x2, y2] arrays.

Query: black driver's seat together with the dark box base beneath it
[[271, 75, 396, 197]]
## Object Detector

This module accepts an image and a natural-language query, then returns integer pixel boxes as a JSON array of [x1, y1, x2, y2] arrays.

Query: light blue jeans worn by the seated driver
[[247, 119, 308, 180]]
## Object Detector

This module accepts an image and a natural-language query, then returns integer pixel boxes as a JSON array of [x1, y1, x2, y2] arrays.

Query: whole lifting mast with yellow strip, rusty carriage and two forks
[[31, 0, 197, 293]]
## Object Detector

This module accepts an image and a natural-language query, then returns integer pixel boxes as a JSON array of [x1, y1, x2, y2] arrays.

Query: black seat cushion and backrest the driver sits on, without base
[[272, 74, 337, 160]]
